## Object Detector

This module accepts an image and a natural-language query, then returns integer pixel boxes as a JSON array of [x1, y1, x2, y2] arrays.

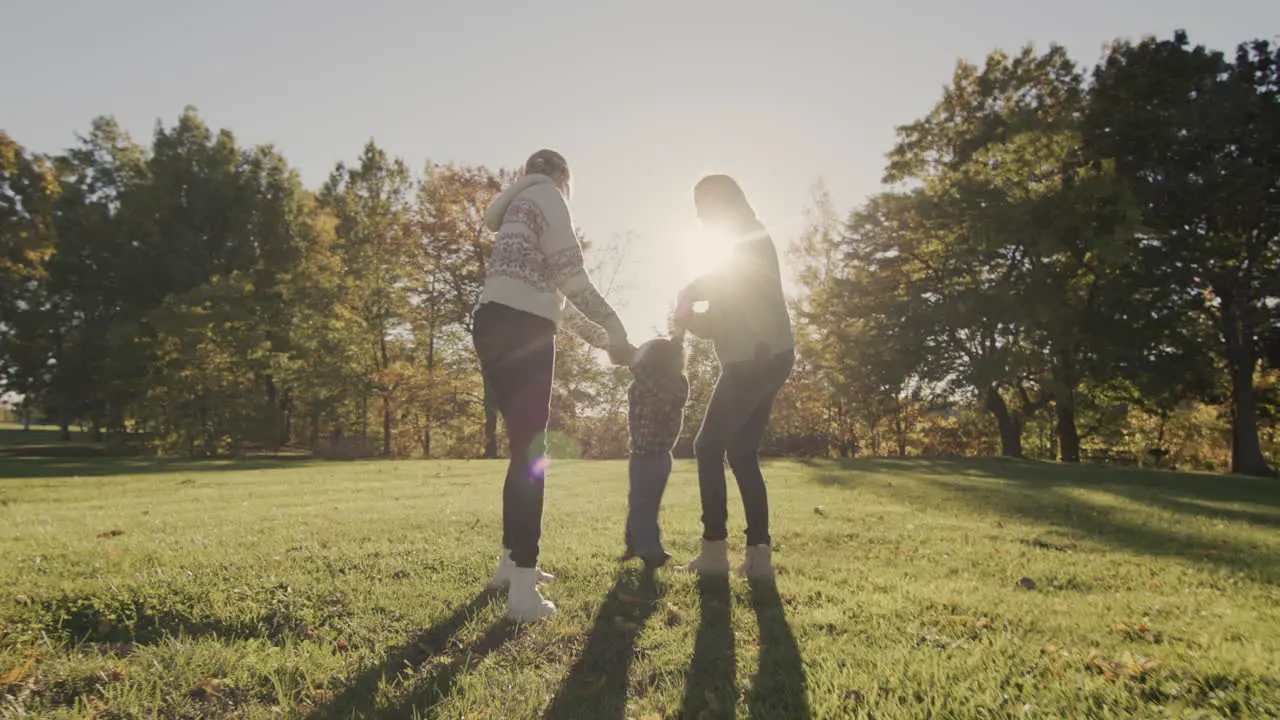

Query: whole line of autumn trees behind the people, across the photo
[[0, 33, 1280, 474]]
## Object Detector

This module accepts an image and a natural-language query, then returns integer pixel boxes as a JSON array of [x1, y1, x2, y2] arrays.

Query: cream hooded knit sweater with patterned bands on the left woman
[[480, 174, 626, 348]]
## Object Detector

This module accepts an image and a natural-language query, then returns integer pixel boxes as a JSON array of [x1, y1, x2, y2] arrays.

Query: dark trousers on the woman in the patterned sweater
[[472, 302, 556, 568]]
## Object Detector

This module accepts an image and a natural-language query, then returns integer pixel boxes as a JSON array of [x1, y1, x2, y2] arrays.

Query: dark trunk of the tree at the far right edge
[[1220, 295, 1271, 475]]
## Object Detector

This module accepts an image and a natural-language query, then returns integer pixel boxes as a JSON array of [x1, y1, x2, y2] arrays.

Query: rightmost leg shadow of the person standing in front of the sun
[[748, 582, 812, 720]]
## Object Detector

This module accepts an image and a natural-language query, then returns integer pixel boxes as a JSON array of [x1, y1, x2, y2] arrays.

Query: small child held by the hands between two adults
[[622, 336, 689, 569]]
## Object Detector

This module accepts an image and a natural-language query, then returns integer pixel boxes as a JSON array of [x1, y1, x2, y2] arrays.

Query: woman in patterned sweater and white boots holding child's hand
[[472, 150, 635, 621]]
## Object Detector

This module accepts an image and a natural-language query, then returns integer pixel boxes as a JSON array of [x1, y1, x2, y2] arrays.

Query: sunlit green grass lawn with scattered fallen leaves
[[0, 456, 1280, 719]]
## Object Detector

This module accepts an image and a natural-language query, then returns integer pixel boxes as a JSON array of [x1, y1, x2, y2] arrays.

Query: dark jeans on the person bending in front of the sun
[[694, 351, 795, 546]]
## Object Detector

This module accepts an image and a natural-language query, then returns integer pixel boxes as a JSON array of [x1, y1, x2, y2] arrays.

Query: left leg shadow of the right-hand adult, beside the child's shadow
[[682, 575, 737, 720]]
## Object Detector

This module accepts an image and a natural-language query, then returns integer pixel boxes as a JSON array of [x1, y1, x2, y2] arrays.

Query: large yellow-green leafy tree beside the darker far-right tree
[[875, 46, 1142, 461]]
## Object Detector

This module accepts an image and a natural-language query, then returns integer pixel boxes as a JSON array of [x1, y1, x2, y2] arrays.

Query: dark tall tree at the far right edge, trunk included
[[1087, 32, 1280, 474]]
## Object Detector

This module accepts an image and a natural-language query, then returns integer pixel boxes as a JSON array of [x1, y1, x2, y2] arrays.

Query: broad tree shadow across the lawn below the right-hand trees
[[818, 460, 1280, 584]]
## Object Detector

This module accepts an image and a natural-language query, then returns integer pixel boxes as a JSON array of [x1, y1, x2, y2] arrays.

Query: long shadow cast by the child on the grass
[[544, 570, 662, 720]]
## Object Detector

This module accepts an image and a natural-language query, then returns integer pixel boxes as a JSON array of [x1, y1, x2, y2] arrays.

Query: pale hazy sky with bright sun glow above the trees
[[0, 0, 1280, 341]]
